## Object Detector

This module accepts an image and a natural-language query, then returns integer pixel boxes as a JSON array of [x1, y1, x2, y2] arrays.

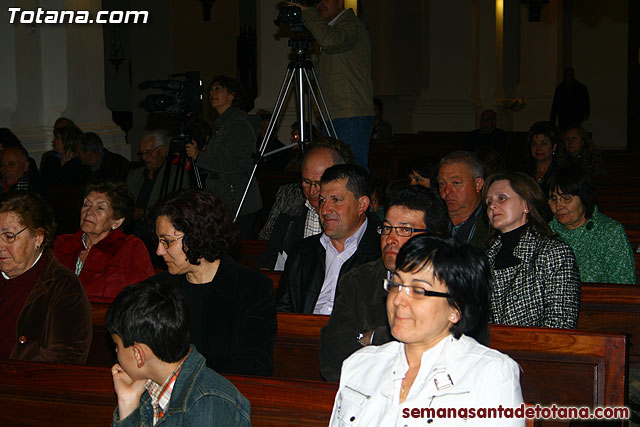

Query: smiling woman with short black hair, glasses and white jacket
[[330, 234, 524, 427]]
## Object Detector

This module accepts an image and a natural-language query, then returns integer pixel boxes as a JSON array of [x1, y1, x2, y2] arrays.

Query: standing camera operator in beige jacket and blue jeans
[[288, 0, 374, 168]]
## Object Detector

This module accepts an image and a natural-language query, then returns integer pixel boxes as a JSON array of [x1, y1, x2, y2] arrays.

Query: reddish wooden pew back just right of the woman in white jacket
[[489, 325, 626, 407]]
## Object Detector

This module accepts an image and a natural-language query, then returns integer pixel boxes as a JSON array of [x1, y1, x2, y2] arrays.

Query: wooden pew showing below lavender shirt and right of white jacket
[[274, 313, 626, 407]]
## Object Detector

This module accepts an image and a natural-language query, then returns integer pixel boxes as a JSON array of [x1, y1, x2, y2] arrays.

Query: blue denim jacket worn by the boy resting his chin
[[111, 346, 251, 427]]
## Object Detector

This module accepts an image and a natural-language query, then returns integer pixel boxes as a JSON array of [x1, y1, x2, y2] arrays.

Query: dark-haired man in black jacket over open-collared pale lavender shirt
[[277, 164, 380, 314]]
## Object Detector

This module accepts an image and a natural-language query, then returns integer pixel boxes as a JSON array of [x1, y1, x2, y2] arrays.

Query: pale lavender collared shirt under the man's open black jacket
[[313, 218, 369, 314]]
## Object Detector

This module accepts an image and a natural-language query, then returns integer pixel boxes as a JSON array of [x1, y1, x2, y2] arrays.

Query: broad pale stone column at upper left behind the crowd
[[0, 0, 129, 166]]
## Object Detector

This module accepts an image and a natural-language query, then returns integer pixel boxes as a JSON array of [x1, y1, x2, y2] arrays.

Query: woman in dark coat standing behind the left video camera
[[186, 76, 262, 239]]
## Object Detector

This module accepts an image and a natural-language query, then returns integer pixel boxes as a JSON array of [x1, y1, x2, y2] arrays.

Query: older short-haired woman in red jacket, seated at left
[[54, 181, 153, 302]]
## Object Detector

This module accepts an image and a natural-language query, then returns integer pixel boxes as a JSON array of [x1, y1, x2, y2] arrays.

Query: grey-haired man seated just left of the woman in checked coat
[[438, 151, 489, 249]]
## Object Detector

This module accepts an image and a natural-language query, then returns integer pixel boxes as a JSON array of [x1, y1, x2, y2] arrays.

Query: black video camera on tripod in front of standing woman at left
[[138, 71, 204, 195]]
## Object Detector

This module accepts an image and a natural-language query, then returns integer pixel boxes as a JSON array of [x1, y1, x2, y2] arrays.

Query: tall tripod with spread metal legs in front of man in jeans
[[234, 35, 338, 221]]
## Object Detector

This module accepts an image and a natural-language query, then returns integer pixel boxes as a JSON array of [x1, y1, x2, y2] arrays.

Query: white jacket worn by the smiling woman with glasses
[[329, 335, 525, 427]]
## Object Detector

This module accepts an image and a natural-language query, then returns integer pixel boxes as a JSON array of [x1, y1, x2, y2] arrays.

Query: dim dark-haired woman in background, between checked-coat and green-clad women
[[527, 122, 560, 194]]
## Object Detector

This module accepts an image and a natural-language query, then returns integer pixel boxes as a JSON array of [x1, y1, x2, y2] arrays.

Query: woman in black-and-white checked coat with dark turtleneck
[[483, 172, 581, 329]]
